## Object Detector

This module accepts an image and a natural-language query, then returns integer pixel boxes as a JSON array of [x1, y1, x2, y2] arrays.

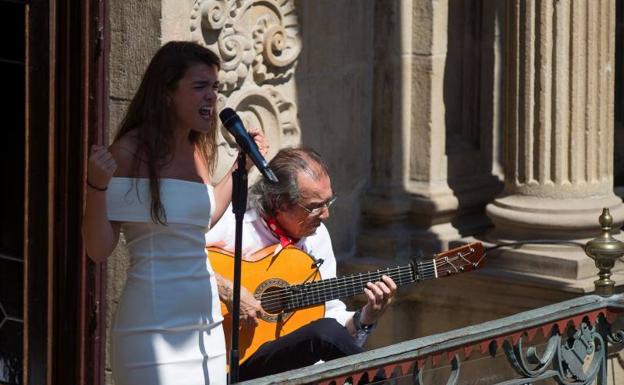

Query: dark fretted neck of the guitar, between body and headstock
[[286, 260, 437, 310]]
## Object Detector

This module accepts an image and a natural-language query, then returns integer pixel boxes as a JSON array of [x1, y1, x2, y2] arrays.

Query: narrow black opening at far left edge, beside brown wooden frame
[[0, 0, 26, 385]]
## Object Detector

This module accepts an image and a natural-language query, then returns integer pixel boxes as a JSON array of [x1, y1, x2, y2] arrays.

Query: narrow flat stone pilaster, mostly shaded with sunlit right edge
[[358, 1, 412, 258]]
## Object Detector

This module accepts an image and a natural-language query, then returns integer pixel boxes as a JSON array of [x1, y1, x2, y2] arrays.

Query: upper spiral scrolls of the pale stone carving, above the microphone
[[190, 0, 301, 93]]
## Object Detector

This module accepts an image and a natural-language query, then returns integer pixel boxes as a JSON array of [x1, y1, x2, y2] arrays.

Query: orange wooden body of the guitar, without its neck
[[208, 246, 325, 364]]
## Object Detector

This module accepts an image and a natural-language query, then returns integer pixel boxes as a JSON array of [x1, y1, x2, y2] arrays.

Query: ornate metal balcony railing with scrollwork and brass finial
[[241, 209, 624, 385]]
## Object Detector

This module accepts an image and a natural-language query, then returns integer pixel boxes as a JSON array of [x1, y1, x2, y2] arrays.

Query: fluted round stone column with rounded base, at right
[[487, 0, 624, 290]]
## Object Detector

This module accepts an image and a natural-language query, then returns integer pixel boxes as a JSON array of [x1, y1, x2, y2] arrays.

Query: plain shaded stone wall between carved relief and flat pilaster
[[294, 0, 375, 255]]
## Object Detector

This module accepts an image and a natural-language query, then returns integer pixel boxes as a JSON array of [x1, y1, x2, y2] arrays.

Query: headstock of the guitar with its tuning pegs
[[432, 242, 485, 277]]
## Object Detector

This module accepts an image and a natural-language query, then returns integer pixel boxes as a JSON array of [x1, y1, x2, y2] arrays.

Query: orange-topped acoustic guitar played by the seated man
[[208, 242, 485, 364]]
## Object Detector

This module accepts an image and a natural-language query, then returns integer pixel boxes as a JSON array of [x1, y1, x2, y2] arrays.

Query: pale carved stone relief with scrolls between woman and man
[[190, 0, 301, 174]]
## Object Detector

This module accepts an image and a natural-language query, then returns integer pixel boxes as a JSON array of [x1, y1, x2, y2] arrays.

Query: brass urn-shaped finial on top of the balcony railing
[[585, 208, 624, 296]]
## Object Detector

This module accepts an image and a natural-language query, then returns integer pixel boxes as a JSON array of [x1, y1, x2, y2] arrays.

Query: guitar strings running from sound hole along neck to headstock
[[260, 253, 472, 310]]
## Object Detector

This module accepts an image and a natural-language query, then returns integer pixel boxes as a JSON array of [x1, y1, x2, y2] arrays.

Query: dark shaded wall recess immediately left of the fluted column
[[444, 0, 505, 236]]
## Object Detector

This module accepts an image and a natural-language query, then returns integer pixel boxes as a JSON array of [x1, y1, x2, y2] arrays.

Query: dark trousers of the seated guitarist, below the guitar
[[239, 318, 363, 381]]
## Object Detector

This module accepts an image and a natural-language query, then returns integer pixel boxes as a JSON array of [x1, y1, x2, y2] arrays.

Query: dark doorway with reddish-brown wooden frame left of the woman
[[0, 0, 108, 385]]
